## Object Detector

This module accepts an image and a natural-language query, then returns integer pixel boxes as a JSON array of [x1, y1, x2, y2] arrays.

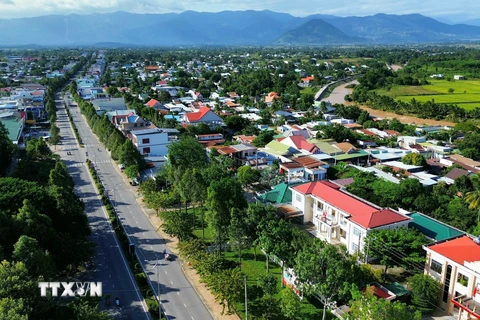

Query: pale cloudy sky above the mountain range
[[0, 0, 480, 22]]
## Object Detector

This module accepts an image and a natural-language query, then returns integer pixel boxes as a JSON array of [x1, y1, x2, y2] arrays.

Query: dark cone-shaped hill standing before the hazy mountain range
[[274, 19, 361, 45]]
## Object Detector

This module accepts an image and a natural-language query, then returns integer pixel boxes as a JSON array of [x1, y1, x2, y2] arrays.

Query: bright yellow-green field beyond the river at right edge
[[377, 79, 480, 110]]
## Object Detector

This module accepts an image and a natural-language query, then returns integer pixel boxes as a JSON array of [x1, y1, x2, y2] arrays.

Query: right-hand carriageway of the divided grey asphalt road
[[61, 94, 213, 320]]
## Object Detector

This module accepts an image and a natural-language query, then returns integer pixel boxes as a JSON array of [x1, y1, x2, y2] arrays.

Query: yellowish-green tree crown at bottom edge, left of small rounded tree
[[349, 286, 422, 320]]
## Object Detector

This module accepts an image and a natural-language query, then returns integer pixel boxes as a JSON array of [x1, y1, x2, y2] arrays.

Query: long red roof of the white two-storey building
[[293, 181, 408, 229]]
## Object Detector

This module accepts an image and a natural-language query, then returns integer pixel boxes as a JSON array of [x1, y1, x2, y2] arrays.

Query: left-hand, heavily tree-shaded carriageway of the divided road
[[56, 96, 151, 320]]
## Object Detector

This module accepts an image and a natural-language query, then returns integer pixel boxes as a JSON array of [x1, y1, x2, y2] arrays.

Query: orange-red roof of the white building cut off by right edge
[[427, 236, 480, 265]]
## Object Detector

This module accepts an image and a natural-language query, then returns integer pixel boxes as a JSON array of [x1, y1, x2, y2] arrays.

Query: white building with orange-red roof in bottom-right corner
[[424, 235, 480, 319]]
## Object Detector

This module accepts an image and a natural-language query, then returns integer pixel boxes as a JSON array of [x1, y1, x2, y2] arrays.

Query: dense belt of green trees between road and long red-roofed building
[[135, 136, 436, 319]]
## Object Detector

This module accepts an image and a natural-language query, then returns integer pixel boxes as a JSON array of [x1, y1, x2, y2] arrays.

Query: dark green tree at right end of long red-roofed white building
[[365, 227, 429, 274]]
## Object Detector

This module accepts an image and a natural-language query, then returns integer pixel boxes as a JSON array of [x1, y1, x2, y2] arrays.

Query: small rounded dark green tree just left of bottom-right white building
[[408, 273, 442, 314]]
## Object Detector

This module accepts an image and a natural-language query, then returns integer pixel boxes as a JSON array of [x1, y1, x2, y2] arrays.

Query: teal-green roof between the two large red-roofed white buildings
[[407, 212, 465, 241]]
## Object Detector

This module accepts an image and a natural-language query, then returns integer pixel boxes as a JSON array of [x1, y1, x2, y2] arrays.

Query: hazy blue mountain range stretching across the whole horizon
[[0, 10, 480, 46]]
